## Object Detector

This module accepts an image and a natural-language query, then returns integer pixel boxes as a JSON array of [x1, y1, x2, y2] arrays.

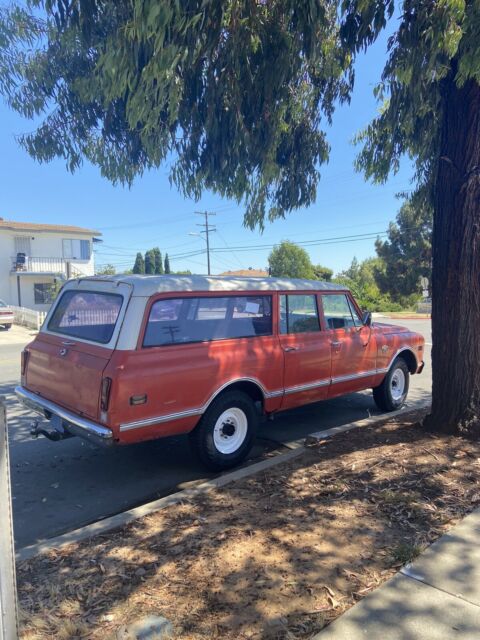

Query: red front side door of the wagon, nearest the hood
[[321, 293, 377, 397]]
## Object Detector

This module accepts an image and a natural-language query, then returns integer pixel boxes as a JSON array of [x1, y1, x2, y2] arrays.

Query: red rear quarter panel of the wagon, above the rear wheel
[[105, 336, 283, 443]]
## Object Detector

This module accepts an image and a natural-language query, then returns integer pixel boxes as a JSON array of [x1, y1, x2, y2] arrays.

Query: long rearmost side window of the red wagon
[[143, 296, 272, 347]]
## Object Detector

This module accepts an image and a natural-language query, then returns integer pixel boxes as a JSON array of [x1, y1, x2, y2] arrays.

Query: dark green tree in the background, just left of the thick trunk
[[375, 192, 432, 302]]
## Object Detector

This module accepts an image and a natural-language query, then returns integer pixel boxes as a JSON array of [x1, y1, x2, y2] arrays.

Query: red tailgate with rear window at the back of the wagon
[[24, 287, 129, 419]]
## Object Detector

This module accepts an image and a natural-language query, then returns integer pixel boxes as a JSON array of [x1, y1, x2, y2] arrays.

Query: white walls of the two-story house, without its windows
[[0, 229, 95, 311]]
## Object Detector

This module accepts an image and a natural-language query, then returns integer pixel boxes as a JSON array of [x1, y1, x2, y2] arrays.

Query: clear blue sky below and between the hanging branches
[[0, 19, 412, 273]]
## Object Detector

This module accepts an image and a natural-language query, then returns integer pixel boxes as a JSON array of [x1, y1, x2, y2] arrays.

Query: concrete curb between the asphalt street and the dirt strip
[[15, 401, 430, 562]]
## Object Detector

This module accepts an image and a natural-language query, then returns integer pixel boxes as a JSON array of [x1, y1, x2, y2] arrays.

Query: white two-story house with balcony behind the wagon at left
[[0, 218, 102, 311]]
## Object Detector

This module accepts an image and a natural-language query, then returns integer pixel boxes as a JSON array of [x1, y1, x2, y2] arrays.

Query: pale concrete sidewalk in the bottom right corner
[[315, 509, 480, 640]]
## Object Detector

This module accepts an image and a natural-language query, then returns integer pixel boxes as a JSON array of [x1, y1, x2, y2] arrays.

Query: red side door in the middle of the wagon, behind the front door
[[278, 293, 331, 409]]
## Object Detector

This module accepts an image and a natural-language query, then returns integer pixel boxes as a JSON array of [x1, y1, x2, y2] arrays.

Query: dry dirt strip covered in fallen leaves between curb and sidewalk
[[18, 414, 480, 640]]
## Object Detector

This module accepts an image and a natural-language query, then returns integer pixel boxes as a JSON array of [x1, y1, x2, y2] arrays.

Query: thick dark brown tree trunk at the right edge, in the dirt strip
[[425, 65, 480, 438]]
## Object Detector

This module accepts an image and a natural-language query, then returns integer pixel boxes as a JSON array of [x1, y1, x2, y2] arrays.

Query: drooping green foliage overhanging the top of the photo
[[0, 0, 480, 227]]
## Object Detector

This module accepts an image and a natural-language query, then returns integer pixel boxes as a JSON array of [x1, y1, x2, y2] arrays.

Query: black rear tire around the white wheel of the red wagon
[[190, 391, 258, 471]]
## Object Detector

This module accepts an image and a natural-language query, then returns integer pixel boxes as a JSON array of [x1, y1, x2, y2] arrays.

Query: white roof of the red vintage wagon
[[71, 275, 348, 297]]
